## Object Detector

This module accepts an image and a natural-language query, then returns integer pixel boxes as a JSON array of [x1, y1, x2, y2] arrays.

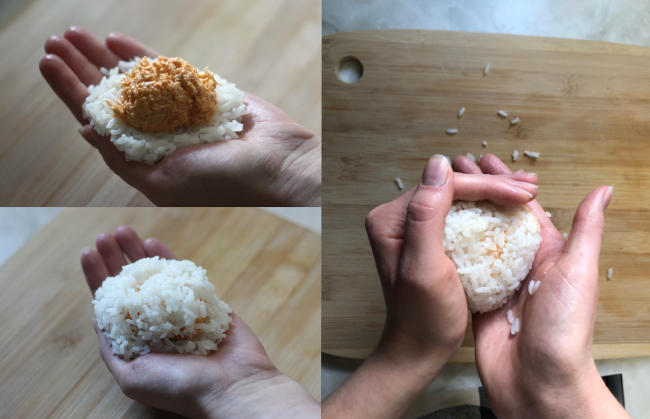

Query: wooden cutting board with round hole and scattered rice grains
[[322, 31, 650, 361]]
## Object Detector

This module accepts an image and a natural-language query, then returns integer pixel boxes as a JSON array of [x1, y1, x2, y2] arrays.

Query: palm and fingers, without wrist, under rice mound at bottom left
[[81, 226, 279, 416]]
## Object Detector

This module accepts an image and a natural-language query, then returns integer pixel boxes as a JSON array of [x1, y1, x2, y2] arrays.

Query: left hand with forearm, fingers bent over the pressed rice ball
[[324, 156, 537, 417]]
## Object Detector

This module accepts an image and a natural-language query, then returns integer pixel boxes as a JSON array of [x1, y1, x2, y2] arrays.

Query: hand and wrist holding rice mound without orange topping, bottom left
[[81, 226, 320, 417]]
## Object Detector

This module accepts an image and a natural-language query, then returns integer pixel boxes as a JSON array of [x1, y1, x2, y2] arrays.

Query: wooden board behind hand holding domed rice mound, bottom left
[[0, 208, 320, 418]]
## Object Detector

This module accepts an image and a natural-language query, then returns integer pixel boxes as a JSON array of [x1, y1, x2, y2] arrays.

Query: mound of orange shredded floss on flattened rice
[[108, 57, 217, 132]]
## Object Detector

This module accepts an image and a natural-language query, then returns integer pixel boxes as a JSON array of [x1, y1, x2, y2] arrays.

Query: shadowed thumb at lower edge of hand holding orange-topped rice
[[79, 125, 151, 189]]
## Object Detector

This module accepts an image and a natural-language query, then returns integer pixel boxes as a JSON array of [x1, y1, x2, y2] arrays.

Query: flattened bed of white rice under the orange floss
[[83, 57, 247, 165]]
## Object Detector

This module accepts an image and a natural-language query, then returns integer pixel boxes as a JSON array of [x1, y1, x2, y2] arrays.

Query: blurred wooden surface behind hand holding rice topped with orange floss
[[0, 0, 321, 206]]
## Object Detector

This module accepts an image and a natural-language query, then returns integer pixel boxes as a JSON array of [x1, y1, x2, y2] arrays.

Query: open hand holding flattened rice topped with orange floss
[[40, 26, 321, 206]]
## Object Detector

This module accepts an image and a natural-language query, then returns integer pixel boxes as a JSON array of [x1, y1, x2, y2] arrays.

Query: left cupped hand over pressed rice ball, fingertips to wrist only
[[366, 156, 537, 370]]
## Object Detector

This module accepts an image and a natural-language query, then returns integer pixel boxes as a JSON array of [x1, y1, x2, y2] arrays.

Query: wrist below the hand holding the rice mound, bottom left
[[200, 369, 320, 418]]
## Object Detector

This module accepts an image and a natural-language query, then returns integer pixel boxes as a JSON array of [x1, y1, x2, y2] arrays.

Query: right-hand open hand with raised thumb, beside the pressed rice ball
[[454, 154, 627, 418]]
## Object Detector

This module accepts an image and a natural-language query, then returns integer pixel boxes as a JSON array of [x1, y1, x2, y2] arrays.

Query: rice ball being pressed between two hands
[[444, 201, 542, 313]]
